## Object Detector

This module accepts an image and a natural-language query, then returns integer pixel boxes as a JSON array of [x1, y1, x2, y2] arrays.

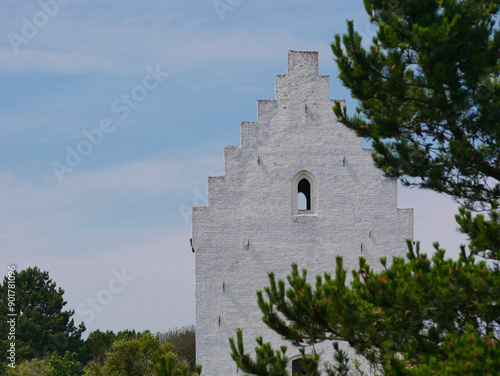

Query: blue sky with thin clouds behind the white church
[[0, 0, 463, 334]]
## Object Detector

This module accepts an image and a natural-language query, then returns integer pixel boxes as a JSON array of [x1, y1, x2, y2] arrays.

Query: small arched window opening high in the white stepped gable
[[292, 170, 316, 215]]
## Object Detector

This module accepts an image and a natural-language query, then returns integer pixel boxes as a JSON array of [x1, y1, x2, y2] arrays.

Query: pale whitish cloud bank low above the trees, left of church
[[13, 226, 195, 335]]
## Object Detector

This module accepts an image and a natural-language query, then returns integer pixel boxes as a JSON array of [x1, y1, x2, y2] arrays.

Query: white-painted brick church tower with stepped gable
[[192, 51, 413, 376]]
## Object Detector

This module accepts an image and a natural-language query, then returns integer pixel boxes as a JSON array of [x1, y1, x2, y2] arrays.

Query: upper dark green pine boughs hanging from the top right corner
[[332, 0, 500, 207]]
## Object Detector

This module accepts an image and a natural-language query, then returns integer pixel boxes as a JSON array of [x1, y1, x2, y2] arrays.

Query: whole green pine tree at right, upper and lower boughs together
[[230, 0, 500, 376]]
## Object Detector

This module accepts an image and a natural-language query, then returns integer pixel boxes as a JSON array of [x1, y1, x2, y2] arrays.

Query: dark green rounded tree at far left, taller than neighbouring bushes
[[0, 267, 85, 366]]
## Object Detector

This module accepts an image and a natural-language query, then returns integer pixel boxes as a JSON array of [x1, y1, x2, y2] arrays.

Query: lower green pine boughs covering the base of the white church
[[231, 243, 500, 375]]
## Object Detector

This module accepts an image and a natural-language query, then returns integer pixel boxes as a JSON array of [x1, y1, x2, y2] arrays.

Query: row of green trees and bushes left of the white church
[[0, 267, 200, 376]]
